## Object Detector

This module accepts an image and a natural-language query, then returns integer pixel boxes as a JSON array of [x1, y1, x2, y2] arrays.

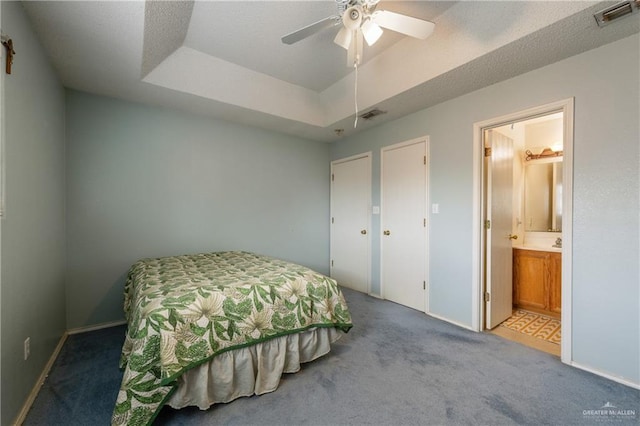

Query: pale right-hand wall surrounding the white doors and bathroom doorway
[[331, 34, 640, 383]]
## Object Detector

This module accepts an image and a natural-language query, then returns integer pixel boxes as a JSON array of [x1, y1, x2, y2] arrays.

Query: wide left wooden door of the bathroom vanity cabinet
[[514, 250, 548, 309]]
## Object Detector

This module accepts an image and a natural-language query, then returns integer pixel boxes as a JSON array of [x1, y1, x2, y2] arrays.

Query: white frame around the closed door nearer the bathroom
[[380, 135, 431, 314]]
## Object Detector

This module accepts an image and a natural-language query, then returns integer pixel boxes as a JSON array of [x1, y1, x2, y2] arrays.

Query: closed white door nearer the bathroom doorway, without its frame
[[381, 139, 427, 312]]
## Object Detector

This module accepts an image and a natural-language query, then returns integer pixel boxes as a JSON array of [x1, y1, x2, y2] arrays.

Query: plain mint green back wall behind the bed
[[67, 91, 330, 328]]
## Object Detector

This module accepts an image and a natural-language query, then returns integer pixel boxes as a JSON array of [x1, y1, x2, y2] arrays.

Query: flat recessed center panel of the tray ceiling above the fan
[[184, 0, 454, 92]]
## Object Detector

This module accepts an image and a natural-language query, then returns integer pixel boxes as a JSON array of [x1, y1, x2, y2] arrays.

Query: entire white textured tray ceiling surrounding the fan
[[21, 0, 640, 142]]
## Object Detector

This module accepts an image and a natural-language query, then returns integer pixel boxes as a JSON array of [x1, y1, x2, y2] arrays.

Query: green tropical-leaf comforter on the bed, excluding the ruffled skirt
[[112, 252, 352, 425]]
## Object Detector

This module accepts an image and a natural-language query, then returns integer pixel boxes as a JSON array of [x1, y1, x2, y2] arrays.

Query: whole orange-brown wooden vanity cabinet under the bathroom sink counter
[[513, 249, 562, 317]]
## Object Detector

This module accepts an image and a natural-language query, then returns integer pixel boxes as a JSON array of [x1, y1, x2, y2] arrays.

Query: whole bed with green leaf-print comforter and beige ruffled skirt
[[112, 251, 353, 425]]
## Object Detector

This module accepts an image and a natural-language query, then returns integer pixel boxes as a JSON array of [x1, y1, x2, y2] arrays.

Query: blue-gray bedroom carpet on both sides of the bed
[[24, 290, 640, 426]]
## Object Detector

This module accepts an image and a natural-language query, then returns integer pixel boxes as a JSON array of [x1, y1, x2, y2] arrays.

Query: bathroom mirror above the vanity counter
[[524, 157, 562, 232]]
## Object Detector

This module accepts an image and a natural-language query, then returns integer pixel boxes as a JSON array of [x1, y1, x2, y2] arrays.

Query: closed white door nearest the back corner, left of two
[[330, 154, 371, 293]]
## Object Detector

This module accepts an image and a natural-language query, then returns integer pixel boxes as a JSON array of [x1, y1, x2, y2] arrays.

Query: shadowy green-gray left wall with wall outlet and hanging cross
[[0, 2, 66, 425]]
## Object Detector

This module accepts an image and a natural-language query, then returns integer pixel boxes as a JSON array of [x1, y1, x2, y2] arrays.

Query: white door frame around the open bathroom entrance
[[471, 98, 574, 364]]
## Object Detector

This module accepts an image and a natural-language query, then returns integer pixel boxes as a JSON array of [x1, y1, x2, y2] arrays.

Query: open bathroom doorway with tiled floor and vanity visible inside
[[474, 99, 573, 361]]
